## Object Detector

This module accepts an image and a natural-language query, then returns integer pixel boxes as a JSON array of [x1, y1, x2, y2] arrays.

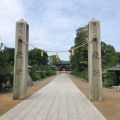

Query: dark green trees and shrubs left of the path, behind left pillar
[[0, 44, 56, 87]]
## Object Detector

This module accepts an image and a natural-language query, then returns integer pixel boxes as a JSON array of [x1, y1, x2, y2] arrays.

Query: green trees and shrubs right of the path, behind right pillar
[[70, 26, 120, 87]]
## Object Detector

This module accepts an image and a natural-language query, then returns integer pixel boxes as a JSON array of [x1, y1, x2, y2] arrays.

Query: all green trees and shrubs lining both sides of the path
[[0, 26, 120, 87]]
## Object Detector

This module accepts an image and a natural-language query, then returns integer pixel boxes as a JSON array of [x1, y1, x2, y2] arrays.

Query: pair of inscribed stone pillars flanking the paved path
[[13, 18, 102, 101]]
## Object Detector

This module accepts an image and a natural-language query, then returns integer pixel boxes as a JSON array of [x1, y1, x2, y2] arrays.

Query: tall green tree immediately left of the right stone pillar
[[70, 26, 88, 72]]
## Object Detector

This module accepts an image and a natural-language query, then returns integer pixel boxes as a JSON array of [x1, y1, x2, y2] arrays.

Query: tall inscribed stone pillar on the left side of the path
[[13, 19, 29, 100]]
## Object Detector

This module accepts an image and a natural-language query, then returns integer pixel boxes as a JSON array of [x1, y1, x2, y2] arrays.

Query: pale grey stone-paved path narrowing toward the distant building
[[0, 73, 105, 120]]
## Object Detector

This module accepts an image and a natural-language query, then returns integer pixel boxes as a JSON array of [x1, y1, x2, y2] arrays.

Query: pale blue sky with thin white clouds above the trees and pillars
[[0, 0, 120, 61]]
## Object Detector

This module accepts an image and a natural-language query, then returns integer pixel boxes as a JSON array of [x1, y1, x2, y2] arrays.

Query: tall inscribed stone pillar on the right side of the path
[[88, 18, 102, 101]]
